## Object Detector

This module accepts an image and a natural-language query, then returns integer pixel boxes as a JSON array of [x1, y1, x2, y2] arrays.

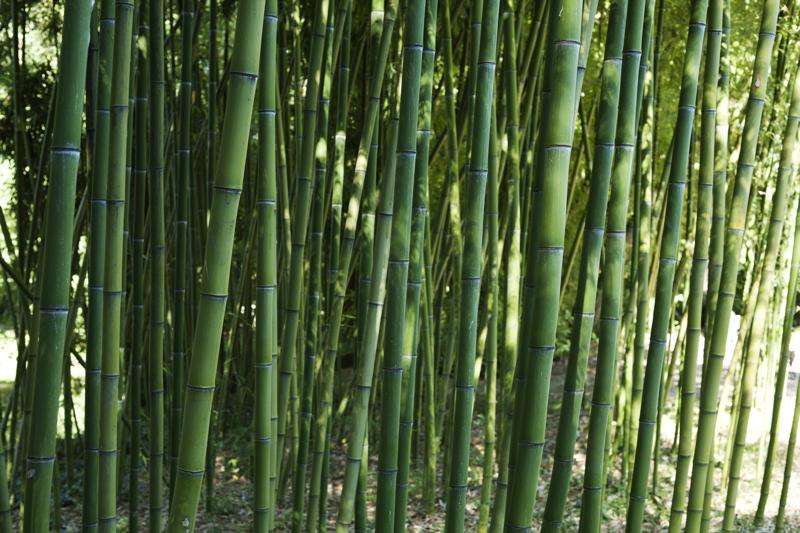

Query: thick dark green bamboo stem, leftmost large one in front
[[22, 1, 92, 533]]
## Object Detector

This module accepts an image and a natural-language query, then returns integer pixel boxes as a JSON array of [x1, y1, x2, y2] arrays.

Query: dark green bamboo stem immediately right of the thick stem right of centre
[[542, 0, 628, 520]]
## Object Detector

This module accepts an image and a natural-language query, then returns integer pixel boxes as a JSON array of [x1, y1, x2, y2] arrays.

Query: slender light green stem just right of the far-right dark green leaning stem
[[664, 0, 722, 533]]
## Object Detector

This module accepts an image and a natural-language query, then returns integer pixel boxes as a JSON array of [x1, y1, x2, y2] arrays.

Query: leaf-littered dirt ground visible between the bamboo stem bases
[[62, 358, 800, 533]]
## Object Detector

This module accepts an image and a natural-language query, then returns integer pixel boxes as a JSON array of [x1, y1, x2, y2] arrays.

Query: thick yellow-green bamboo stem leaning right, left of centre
[[168, 0, 264, 533]]
